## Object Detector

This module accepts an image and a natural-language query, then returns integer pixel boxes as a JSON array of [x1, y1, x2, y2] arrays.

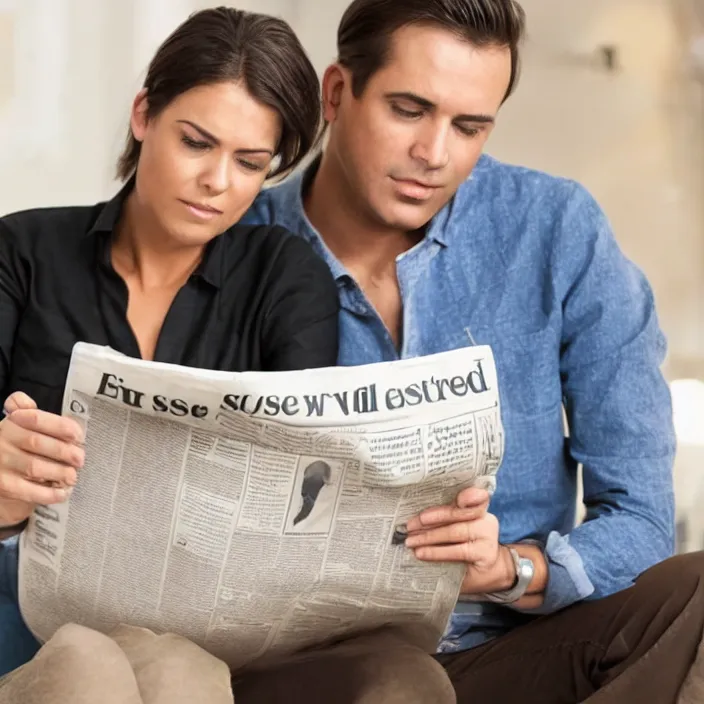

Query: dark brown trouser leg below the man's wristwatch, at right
[[437, 552, 704, 704]]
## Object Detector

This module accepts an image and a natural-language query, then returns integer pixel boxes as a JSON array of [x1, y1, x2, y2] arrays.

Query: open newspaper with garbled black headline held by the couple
[[19, 343, 503, 670]]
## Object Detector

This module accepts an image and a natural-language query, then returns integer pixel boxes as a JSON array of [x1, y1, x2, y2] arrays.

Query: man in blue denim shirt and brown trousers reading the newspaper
[[239, 0, 704, 704]]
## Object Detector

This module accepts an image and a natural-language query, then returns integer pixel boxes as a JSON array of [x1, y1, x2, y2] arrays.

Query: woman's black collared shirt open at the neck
[[0, 187, 339, 413]]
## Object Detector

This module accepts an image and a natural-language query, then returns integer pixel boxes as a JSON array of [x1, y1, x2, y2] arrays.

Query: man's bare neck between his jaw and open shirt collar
[[303, 154, 422, 276]]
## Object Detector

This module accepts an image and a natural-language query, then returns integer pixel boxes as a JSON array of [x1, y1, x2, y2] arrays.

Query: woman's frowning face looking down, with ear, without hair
[[131, 82, 281, 246]]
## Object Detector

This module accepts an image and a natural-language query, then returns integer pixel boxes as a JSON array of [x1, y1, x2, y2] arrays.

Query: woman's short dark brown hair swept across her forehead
[[117, 7, 321, 181]]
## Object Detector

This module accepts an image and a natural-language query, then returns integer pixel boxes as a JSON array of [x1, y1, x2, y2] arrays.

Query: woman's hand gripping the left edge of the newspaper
[[0, 392, 85, 528]]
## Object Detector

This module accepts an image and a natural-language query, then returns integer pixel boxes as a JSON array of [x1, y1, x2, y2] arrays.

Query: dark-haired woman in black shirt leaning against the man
[[0, 8, 338, 673]]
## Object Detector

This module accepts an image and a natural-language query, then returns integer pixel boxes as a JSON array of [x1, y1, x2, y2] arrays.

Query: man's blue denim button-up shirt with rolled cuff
[[245, 156, 675, 651]]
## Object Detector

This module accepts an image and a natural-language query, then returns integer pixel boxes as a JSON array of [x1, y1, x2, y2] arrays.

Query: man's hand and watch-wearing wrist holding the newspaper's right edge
[[406, 488, 547, 608]]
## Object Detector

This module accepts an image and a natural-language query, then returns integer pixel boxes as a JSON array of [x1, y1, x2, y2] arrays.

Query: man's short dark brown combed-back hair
[[337, 0, 525, 100]]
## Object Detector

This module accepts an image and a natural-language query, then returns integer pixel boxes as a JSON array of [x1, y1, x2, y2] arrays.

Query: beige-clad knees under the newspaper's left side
[[0, 624, 234, 704]]
